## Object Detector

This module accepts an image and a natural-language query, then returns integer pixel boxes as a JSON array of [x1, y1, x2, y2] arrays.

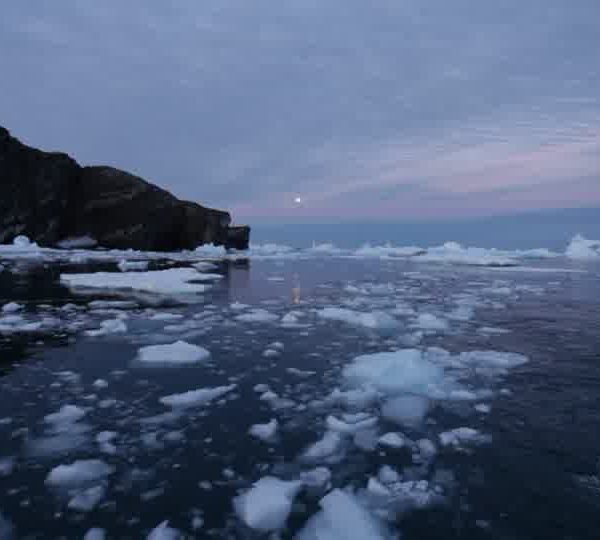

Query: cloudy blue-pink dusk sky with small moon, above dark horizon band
[[0, 0, 600, 223]]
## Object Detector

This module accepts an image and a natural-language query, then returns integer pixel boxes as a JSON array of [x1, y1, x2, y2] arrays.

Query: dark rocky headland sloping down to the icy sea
[[0, 126, 250, 251]]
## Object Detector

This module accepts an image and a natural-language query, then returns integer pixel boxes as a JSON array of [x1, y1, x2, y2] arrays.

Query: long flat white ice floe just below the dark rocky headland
[[60, 268, 208, 295]]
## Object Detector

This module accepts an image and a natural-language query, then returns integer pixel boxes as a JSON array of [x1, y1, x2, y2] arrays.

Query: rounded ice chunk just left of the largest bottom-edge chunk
[[234, 476, 302, 532]]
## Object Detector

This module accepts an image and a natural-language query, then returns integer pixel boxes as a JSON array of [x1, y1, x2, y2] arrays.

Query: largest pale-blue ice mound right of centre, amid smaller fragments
[[342, 349, 444, 395]]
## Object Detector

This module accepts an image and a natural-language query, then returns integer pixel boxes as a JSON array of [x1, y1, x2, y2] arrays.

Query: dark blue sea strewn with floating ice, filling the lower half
[[0, 241, 600, 540]]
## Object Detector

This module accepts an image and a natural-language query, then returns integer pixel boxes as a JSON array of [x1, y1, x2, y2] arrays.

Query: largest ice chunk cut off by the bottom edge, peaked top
[[296, 489, 392, 540]]
